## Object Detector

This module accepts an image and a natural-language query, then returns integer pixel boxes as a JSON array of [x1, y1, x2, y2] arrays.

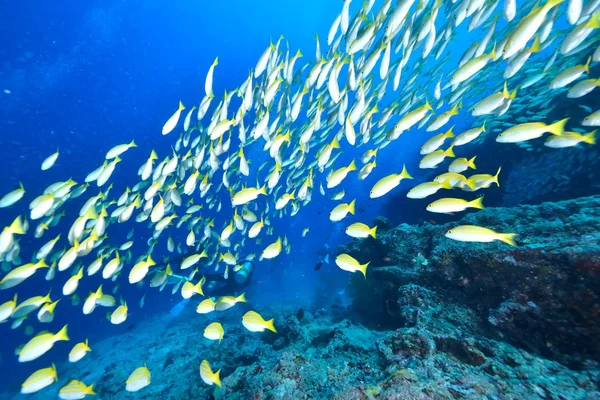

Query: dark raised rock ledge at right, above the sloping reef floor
[[339, 196, 600, 369]]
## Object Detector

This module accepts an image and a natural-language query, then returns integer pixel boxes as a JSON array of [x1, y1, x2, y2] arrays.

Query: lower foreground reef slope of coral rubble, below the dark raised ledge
[[8, 298, 600, 400]]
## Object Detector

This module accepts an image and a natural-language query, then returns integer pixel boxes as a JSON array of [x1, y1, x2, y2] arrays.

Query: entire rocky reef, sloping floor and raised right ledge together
[[5, 196, 600, 400]]
